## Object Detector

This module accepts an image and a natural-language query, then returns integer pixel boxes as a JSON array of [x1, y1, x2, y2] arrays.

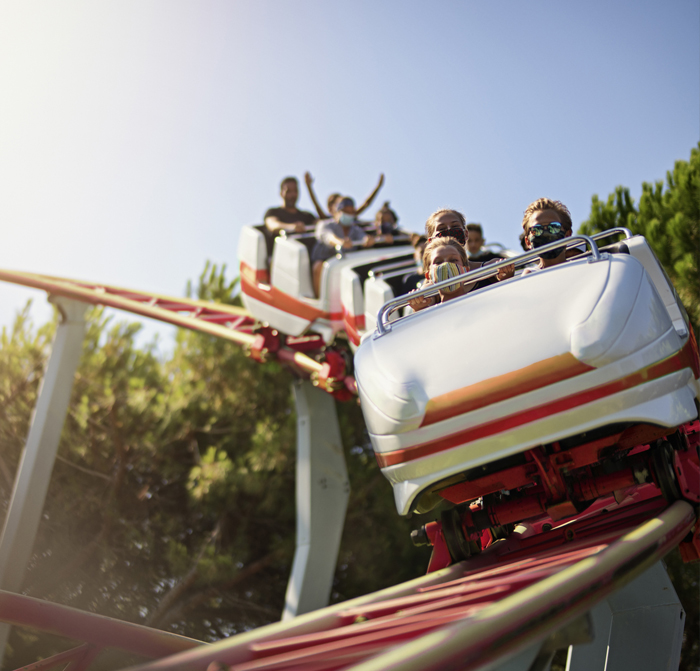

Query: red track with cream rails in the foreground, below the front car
[[0, 496, 684, 671]]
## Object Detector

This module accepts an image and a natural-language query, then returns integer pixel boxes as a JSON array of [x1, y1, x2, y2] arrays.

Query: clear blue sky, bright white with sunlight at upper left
[[0, 0, 700, 349]]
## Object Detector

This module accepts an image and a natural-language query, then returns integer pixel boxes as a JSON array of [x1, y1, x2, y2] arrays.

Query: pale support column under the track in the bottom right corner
[[566, 563, 685, 671]]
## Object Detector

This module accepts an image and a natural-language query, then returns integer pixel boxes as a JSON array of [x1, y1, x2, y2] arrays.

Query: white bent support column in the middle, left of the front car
[[282, 381, 350, 620]]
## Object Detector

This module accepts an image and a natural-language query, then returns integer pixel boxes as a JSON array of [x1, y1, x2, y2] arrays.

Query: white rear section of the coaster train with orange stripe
[[239, 225, 415, 347]]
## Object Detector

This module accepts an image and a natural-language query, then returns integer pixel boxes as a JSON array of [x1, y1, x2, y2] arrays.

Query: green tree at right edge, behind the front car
[[580, 144, 700, 334]]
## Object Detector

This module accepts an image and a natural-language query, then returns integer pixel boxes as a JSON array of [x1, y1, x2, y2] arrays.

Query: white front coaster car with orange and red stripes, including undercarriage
[[355, 229, 700, 558]]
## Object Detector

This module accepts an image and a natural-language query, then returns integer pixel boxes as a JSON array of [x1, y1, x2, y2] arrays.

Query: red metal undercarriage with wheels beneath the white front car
[[413, 421, 700, 573]]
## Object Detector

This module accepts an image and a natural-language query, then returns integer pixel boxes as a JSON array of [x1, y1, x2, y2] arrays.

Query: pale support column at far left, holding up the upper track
[[0, 297, 87, 662]]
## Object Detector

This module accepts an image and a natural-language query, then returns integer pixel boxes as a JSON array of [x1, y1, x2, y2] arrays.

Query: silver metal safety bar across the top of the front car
[[374, 235, 601, 338]]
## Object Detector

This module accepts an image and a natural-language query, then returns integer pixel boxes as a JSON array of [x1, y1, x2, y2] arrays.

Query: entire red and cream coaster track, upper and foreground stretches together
[[0, 270, 700, 671]]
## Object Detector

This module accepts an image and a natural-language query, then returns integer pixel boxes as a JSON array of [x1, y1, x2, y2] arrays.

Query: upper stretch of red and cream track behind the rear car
[[0, 269, 356, 400]]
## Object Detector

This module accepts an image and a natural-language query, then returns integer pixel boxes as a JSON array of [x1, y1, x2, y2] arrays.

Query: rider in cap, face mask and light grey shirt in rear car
[[311, 196, 374, 296]]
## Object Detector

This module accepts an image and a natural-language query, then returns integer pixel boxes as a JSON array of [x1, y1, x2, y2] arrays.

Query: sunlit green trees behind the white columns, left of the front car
[[0, 264, 427, 668]]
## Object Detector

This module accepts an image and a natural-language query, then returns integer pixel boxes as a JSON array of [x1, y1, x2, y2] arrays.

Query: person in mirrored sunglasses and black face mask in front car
[[523, 198, 572, 274]]
